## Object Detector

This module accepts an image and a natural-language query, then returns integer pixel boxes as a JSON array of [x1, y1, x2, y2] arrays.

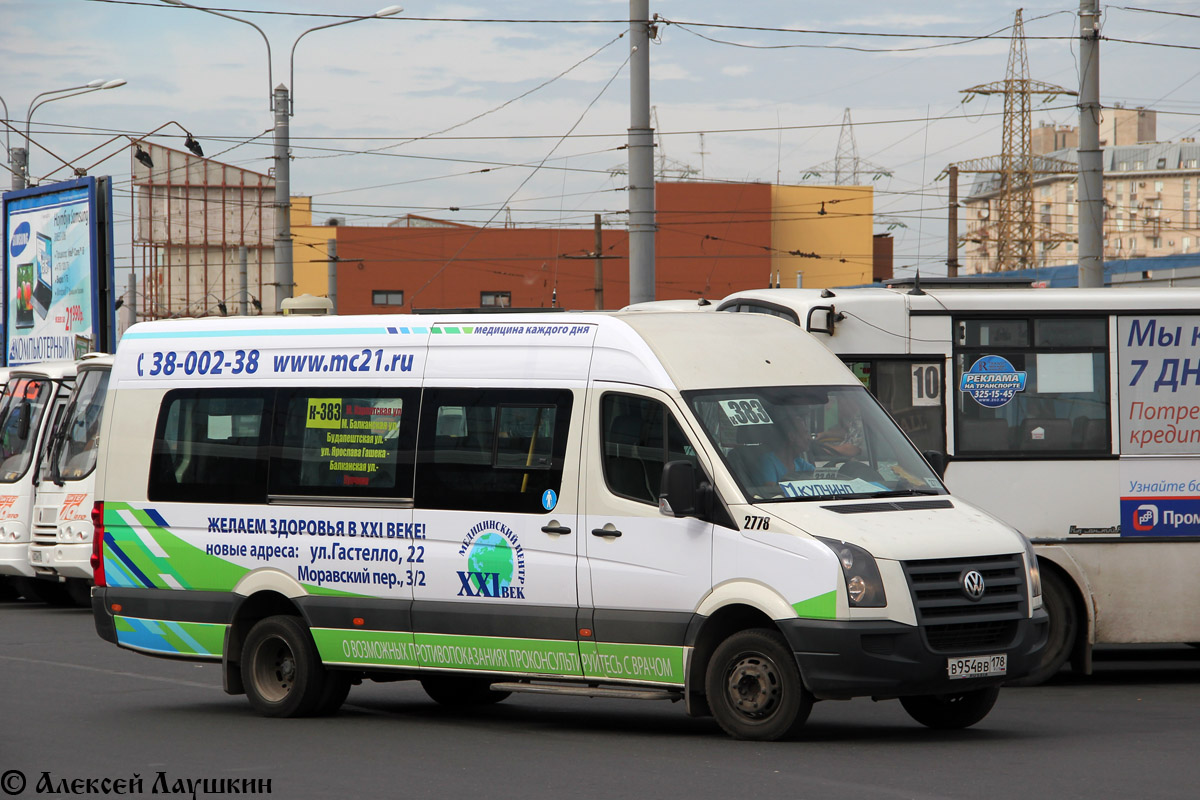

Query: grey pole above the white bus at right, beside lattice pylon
[[1079, 0, 1104, 289]]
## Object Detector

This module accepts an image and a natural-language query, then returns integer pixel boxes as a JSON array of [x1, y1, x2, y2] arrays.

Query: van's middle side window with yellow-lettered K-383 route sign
[[270, 389, 418, 499]]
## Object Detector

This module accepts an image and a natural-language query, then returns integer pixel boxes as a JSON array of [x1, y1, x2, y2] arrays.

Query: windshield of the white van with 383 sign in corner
[[684, 386, 946, 501]]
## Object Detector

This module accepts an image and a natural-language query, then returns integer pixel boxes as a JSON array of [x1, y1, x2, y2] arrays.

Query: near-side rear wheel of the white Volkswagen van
[[241, 615, 328, 717]]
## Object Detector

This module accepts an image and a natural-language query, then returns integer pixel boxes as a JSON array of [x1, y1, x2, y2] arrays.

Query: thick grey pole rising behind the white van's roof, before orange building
[[629, 0, 655, 303]]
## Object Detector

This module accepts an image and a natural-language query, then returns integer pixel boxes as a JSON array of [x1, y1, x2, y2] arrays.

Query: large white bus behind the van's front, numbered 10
[[718, 287, 1200, 682]]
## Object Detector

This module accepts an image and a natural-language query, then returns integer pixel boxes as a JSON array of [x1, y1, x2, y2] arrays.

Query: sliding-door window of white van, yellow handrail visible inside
[[415, 389, 572, 513]]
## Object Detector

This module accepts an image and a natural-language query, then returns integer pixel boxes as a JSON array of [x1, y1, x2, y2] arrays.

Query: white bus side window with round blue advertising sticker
[[953, 317, 1111, 457]]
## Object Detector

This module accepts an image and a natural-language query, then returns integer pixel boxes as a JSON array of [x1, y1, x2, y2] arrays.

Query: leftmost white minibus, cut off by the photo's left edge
[[0, 361, 76, 603]]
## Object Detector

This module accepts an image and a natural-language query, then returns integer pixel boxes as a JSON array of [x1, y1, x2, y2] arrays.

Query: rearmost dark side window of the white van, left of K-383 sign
[[148, 389, 271, 503]]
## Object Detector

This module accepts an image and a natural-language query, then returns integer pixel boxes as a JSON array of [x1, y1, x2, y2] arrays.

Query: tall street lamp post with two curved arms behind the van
[[160, 0, 403, 312]]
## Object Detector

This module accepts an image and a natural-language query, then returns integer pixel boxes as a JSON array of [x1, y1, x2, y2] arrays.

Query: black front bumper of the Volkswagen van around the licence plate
[[779, 608, 1048, 699]]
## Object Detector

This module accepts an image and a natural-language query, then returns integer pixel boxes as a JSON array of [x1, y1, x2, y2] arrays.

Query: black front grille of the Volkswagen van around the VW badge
[[904, 553, 1028, 651]]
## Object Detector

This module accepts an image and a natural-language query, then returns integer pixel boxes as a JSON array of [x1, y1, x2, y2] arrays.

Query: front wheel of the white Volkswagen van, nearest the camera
[[704, 628, 812, 741]]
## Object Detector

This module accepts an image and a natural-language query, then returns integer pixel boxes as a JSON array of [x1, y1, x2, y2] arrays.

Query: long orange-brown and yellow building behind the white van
[[292, 182, 872, 314]]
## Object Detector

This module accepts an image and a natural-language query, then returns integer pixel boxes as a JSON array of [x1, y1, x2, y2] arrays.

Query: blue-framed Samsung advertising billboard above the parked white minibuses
[[4, 178, 114, 367]]
